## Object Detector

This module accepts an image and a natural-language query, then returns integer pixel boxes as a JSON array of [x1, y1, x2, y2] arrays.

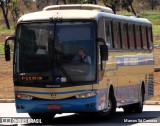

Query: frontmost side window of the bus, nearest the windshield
[[105, 20, 113, 48]]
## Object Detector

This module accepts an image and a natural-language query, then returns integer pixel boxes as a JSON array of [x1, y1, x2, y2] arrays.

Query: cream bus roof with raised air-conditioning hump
[[18, 4, 151, 24]]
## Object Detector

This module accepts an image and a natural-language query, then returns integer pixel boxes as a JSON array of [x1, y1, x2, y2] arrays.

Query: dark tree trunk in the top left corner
[[0, 0, 10, 29]]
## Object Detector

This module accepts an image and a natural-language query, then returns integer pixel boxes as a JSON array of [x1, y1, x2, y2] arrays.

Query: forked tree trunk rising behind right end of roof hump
[[103, 0, 121, 14]]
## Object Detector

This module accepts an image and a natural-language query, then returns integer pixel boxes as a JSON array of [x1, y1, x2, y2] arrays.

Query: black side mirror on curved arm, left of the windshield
[[4, 36, 14, 61]]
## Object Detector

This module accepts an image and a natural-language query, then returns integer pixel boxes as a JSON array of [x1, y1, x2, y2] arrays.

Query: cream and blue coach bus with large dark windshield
[[4, 4, 154, 121]]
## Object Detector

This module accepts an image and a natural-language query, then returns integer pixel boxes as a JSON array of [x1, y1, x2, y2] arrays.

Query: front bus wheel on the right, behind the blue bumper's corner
[[100, 92, 117, 118]]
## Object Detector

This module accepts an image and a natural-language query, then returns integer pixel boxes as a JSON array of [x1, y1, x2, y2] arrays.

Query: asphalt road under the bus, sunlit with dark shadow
[[0, 103, 160, 126]]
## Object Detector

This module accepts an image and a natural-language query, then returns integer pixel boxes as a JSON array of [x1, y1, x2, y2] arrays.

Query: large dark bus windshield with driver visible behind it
[[15, 22, 96, 83]]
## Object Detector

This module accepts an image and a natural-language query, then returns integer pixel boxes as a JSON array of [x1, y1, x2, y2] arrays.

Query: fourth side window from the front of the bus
[[128, 24, 135, 49]]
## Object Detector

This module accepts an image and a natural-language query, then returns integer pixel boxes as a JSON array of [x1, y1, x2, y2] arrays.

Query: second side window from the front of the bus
[[113, 21, 121, 49]]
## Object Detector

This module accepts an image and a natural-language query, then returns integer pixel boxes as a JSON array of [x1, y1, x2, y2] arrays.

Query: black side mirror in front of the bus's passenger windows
[[100, 45, 108, 61]]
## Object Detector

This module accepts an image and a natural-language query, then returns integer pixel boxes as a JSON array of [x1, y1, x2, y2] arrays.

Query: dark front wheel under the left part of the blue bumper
[[28, 113, 56, 123]]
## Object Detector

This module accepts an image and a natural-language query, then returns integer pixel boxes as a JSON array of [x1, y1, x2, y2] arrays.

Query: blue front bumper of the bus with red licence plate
[[16, 96, 98, 113]]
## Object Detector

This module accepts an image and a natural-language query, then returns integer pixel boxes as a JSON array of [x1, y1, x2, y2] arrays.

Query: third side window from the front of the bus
[[121, 23, 128, 49]]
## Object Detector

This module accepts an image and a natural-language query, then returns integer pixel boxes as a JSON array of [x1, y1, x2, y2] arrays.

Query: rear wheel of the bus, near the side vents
[[134, 90, 144, 113]]
